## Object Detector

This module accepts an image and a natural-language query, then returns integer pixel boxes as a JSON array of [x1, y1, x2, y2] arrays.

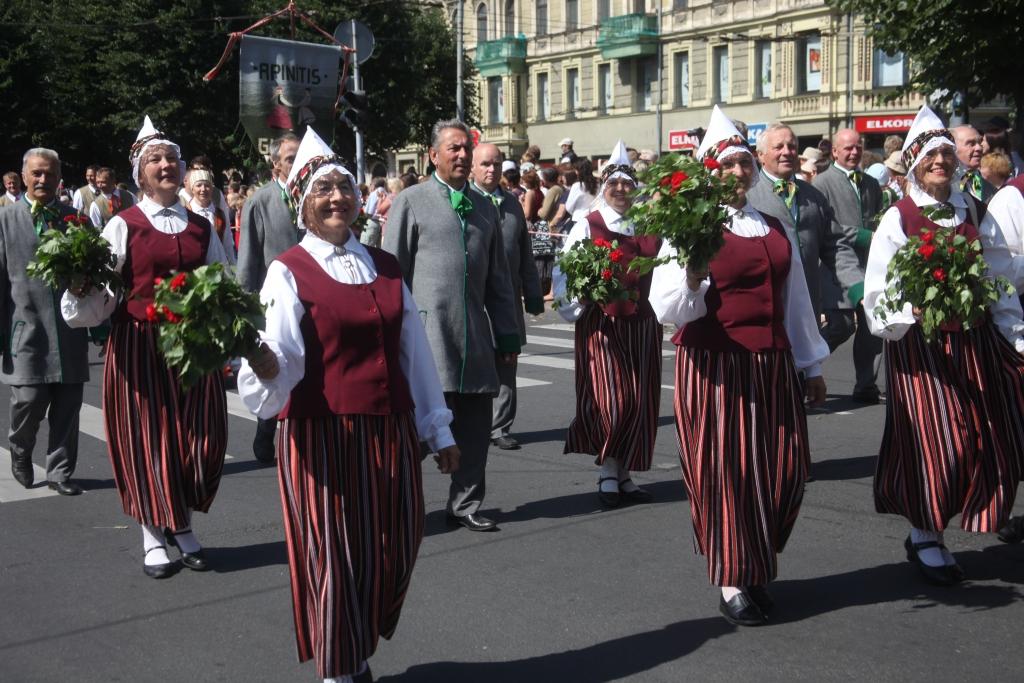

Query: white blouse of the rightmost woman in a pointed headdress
[[864, 183, 1024, 352]]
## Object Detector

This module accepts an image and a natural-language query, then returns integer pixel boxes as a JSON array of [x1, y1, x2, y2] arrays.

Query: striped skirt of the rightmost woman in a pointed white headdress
[[874, 324, 1024, 531]]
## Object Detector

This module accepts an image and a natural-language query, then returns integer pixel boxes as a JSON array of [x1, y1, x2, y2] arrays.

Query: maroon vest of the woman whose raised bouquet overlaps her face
[[672, 214, 790, 352]]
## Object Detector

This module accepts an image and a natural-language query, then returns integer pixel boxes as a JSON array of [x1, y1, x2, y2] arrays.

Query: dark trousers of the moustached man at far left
[[9, 382, 82, 481]]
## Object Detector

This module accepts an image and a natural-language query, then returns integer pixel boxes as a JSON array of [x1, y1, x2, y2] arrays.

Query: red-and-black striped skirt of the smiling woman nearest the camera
[[278, 415, 423, 678]]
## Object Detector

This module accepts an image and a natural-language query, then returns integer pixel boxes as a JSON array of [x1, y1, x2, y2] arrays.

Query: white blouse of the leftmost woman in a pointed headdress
[[60, 197, 227, 328]]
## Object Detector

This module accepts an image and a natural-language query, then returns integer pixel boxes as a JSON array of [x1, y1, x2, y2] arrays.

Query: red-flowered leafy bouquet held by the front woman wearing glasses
[[145, 263, 266, 388]]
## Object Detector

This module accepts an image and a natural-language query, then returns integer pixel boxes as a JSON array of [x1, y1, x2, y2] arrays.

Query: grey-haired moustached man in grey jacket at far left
[[0, 147, 89, 496]]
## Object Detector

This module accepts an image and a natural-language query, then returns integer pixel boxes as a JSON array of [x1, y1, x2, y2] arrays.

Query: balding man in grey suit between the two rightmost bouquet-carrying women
[[814, 128, 882, 404]]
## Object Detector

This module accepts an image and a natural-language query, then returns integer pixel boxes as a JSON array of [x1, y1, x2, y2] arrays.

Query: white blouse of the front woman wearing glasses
[[239, 232, 455, 451]]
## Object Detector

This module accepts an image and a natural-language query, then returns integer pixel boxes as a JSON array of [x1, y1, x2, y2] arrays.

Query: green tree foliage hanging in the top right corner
[[827, 0, 1024, 126]]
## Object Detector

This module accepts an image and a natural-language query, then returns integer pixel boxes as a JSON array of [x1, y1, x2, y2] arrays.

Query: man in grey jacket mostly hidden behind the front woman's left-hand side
[[237, 133, 301, 465]]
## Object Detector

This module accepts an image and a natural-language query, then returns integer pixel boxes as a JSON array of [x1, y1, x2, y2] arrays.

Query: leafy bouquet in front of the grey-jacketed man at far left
[[26, 215, 122, 292]]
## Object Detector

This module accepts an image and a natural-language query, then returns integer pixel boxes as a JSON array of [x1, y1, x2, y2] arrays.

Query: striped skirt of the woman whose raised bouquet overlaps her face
[[675, 346, 810, 586]]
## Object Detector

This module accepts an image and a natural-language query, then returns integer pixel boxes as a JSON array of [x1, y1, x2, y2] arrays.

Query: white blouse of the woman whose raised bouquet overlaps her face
[[650, 203, 828, 378]]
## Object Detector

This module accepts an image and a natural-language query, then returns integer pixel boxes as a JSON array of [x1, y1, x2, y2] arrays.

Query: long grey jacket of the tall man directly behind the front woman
[[382, 177, 520, 394]]
